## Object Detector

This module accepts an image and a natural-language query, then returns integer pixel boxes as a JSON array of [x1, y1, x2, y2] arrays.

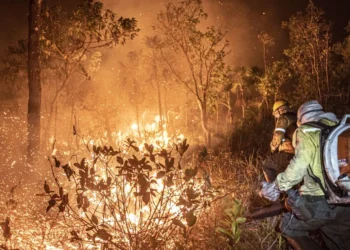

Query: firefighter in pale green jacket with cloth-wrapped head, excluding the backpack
[[260, 101, 350, 250]]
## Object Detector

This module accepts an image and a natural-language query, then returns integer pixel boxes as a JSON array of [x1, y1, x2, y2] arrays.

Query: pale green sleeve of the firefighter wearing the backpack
[[277, 129, 316, 191]]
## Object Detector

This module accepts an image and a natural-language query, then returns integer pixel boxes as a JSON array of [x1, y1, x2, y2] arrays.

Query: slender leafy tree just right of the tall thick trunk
[[42, 0, 139, 146]]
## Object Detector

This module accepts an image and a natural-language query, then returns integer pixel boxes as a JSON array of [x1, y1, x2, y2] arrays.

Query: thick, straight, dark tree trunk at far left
[[27, 0, 42, 164]]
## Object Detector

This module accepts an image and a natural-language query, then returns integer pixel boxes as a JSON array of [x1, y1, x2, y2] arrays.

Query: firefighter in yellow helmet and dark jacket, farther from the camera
[[262, 99, 297, 182]]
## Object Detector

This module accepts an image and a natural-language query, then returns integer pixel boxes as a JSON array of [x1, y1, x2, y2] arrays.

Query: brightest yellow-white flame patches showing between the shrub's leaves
[[9, 115, 197, 250]]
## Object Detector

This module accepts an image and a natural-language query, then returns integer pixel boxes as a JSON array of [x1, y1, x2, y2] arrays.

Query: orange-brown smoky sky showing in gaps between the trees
[[0, 0, 349, 148]]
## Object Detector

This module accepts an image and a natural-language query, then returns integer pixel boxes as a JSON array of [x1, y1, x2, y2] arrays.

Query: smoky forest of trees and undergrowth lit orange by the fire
[[0, 0, 350, 249]]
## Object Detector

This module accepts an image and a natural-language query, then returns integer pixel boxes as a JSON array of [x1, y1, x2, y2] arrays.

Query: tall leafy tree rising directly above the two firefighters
[[282, 1, 331, 103]]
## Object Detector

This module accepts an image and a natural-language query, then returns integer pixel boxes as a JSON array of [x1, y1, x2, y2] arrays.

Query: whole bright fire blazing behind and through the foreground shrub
[[0, 116, 212, 249]]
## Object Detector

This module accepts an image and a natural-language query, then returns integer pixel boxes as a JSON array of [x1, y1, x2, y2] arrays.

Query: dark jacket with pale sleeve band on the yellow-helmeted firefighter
[[270, 111, 297, 154]]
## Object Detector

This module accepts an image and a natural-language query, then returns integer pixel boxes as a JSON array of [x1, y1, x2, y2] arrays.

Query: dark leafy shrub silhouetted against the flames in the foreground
[[44, 136, 213, 249]]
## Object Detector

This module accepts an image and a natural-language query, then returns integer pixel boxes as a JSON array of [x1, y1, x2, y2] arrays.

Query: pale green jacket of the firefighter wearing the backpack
[[277, 119, 336, 196]]
